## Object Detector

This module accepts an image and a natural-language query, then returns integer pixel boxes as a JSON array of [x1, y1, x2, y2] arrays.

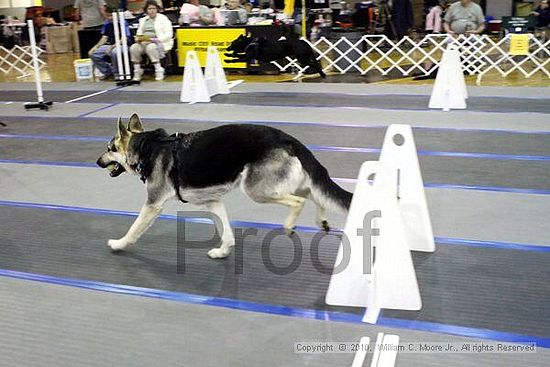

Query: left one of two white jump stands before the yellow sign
[[180, 51, 210, 103]]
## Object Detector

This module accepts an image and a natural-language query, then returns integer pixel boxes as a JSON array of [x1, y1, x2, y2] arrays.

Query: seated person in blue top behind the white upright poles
[[88, 7, 132, 80]]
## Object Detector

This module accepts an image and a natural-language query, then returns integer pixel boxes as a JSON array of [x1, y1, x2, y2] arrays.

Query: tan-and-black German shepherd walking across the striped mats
[[97, 114, 352, 258]]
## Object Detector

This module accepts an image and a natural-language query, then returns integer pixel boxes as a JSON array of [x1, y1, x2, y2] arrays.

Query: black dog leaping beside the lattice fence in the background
[[225, 35, 326, 78]]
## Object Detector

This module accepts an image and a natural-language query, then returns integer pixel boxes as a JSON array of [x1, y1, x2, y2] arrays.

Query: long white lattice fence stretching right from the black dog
[[274, 35, 550, 82]]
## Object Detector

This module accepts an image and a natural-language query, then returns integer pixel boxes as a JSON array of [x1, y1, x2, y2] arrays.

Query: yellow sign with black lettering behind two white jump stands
[[176, 28, 246, 69]]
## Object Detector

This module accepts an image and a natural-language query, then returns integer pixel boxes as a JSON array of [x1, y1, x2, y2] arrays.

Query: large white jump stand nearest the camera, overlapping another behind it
[[326, 162, 422, 323]]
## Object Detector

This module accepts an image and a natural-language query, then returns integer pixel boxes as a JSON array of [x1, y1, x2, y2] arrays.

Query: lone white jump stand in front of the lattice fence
[[429, 44, 468, 111]]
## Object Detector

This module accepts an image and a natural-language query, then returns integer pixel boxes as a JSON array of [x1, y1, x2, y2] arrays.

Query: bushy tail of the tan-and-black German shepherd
[[295, 144, 353, 213]]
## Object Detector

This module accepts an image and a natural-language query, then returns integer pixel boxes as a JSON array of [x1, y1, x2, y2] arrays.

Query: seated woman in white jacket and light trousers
[[130, 0, 174, 81]]
